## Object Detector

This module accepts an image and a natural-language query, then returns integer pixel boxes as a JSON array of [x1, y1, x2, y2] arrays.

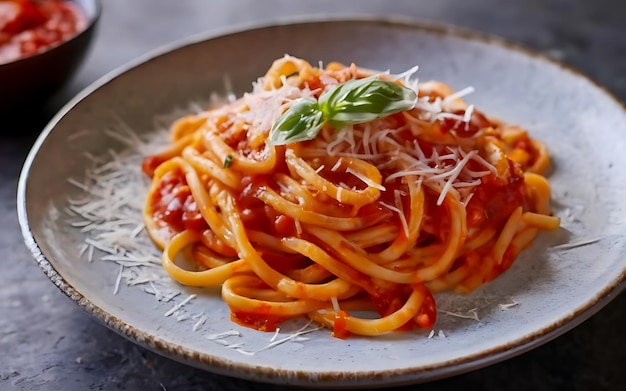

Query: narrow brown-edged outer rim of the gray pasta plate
[[17, 15, 626, 388]]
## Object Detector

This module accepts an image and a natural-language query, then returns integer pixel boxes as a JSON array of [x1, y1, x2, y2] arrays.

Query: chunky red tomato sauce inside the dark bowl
[[0, 0, 87, 64]]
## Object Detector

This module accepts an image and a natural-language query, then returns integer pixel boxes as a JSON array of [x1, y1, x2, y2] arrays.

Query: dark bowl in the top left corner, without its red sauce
[[0, 0, 102, 116]]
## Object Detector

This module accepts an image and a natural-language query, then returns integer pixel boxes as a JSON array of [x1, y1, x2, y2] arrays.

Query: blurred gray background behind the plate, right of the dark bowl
[[22, 0, 626, 125]]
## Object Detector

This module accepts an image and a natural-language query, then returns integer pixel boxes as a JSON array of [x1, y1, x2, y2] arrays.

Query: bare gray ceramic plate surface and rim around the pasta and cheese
[[18, 20, 626, 388]]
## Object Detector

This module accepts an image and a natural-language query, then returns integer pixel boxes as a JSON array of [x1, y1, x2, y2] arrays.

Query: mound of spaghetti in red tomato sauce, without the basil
[[143, 56, 559, 338]]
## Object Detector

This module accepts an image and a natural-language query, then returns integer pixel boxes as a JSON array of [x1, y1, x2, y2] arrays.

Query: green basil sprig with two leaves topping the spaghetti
[[269, 76, 417, 145]]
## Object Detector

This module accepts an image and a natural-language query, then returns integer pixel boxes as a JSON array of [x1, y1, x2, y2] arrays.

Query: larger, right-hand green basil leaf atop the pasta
[[318, 76, 417, 129]]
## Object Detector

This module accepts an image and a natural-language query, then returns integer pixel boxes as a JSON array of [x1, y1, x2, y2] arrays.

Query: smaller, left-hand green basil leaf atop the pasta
[[269, 98, 324, 145]]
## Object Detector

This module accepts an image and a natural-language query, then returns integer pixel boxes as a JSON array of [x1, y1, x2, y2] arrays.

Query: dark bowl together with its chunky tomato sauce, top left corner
[[0, 0, 102, 116]]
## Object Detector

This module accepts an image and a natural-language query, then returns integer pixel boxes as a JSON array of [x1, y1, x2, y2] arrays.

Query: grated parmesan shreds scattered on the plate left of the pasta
[[64, 116, 332, 355]]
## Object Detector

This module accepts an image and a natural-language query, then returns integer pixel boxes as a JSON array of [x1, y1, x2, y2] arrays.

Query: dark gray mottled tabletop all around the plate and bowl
[[0, 0, 626, 390]]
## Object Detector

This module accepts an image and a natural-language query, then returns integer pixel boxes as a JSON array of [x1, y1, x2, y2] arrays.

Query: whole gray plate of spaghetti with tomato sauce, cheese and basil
[[18, 19, 626, 388]]
